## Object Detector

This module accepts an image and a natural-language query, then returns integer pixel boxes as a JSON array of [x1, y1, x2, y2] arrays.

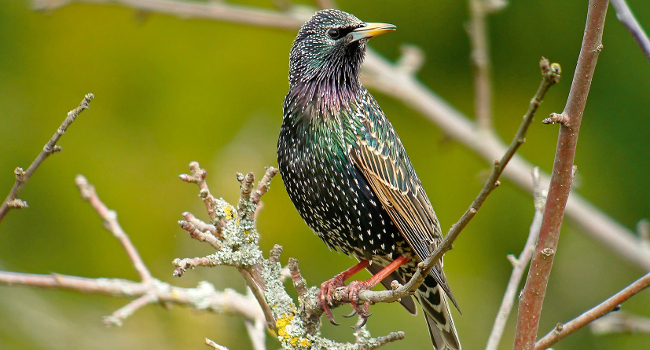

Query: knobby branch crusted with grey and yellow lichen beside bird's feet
[[173, 162, 404, 350]]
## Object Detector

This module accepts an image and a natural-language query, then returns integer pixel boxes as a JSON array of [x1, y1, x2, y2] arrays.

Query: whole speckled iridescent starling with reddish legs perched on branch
[[277, 9, 461, 350]]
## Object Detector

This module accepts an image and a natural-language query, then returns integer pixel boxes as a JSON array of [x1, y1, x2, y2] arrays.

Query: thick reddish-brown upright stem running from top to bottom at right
[[514, 0, 608, 350]]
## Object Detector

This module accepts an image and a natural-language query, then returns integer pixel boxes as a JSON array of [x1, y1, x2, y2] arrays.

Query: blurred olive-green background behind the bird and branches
[[0, 0, 650, 349]]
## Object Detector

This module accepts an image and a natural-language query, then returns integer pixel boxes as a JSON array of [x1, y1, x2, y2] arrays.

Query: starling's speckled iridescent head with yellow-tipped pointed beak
[[289, 10, 395, 88]]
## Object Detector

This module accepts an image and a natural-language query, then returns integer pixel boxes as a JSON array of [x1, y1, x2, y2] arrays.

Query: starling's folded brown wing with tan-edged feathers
[[350, 138, 458, 308]]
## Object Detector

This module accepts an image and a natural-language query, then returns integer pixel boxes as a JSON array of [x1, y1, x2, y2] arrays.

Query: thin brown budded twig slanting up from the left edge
[[0, 93, 95, 222]]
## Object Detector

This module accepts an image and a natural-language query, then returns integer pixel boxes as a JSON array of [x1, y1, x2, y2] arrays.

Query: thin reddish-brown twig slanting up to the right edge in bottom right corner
[[535, 273, 650, 350]]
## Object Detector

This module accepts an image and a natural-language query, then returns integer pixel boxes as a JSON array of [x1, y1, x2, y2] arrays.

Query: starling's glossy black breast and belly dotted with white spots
[[277, 118, 410, 261]]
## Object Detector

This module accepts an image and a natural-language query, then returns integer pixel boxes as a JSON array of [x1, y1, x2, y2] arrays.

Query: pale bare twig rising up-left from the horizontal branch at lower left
[[75, 175, 153, 283]]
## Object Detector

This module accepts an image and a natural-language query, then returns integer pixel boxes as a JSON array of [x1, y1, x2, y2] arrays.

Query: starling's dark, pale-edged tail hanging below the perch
[[417, 275, 461, 350]]
